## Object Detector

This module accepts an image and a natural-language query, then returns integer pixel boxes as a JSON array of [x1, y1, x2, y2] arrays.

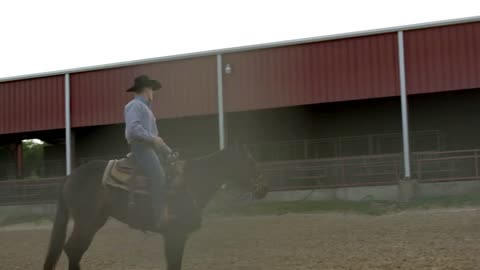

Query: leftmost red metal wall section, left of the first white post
[[0, 76, 65, 134]]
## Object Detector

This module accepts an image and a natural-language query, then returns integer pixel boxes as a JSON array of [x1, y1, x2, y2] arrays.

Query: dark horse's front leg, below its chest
[[164, 232, 187, 270]]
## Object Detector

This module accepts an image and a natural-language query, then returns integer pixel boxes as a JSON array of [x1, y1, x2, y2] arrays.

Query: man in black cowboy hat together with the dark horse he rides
[[43, 75, 267, 270]]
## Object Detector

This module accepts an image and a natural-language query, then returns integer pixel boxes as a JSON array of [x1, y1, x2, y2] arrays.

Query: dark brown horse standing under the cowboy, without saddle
[[44, 148, 264, 270]]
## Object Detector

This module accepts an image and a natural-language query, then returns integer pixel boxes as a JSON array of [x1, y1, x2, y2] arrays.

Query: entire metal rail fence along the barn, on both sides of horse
[[0, 149, 480, 205]]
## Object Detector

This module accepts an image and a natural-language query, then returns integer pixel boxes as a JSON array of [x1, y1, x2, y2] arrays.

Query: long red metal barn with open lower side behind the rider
[[0, 17, 480, 200]]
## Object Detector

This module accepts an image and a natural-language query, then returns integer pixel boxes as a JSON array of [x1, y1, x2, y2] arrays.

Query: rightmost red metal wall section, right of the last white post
[[405, 22, 480, 94]]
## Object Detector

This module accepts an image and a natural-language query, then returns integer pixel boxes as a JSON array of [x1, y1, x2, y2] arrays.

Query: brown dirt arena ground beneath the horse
[[0, 208, 480, 270]]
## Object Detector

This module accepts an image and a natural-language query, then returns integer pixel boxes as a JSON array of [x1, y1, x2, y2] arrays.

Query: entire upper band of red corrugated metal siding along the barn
[[0, 22, 480, 134]]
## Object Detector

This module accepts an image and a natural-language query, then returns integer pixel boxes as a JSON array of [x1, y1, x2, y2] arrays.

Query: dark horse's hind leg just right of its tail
[[65, 218, 107, 270]]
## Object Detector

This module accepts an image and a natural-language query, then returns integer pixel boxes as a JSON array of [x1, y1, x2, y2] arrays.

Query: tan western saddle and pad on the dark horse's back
[[102, 153, 185, 195]]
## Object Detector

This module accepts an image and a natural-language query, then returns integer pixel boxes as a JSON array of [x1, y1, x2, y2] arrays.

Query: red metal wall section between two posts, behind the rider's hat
[[70, 57, 217, 127]]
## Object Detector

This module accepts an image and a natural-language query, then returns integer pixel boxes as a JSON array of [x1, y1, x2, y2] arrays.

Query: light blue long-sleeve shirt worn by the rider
[[124, 96, 158, 145]]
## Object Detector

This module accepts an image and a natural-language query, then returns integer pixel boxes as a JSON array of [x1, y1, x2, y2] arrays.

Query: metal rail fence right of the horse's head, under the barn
[[260, 149, 480, 190]]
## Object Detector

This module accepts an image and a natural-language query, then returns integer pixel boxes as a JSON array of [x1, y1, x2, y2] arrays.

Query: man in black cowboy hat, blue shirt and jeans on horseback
[[124, 75, 169, 228]]
